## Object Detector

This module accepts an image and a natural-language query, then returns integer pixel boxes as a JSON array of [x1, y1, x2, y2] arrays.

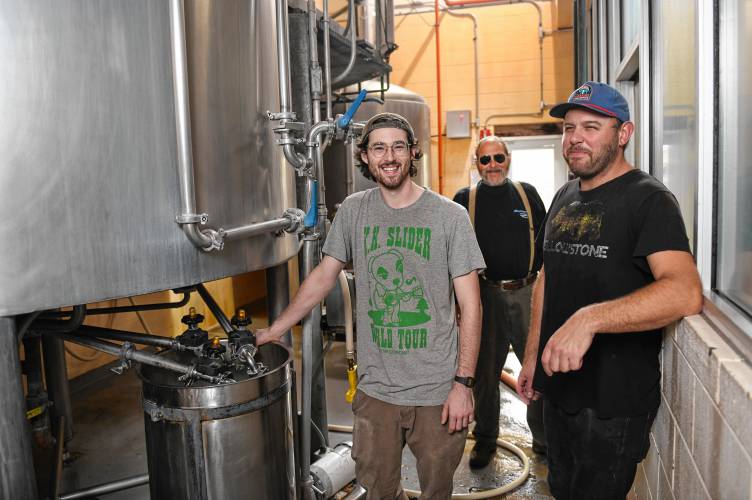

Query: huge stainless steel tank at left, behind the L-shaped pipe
[[0, 0, 298, 316]]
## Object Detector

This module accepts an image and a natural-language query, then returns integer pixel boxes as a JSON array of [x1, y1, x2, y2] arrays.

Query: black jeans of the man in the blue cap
[[543, 400, 657, 500]]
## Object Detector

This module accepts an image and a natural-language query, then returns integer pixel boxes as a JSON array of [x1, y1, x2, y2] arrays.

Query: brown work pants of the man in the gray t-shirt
[[352, 391, 467, 500]]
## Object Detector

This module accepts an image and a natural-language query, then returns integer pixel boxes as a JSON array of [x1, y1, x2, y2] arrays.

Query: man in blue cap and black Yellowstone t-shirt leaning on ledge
[[517, 82, 702, 500]]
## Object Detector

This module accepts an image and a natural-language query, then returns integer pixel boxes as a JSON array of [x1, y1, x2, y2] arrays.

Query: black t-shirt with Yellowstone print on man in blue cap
[[534, 170, 689, 417]]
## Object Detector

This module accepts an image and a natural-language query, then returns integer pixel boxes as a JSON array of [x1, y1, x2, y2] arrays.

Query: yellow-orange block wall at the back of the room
[[390, 0, 574, 197]]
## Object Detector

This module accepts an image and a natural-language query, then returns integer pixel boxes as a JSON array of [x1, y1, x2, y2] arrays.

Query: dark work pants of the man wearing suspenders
[[473, 279, 546, 447]]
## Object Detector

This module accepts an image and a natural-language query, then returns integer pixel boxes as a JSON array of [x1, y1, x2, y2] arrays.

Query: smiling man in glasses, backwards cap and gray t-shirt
[[257, 113, 485, 499]]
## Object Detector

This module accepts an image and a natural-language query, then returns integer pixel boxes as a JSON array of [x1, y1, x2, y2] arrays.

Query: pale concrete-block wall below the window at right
[[630, 316, 752, 500]]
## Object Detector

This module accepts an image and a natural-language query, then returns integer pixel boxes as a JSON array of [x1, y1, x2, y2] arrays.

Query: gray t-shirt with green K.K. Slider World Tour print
[[323, 188, 485, 406]]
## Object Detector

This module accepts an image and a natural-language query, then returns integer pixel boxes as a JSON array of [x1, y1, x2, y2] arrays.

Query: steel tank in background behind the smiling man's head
[[324, 81, 431, 214]]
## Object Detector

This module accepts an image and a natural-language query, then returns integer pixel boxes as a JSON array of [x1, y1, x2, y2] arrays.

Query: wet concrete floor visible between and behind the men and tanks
[[51, 308, 551, 500]]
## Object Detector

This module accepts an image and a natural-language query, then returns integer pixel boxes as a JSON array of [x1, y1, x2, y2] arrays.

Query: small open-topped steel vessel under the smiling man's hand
[[139, 344, 295, 500]]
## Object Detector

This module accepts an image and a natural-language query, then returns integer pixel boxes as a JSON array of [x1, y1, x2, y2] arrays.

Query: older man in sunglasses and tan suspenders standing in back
[[454, 136, 546, 468]]
